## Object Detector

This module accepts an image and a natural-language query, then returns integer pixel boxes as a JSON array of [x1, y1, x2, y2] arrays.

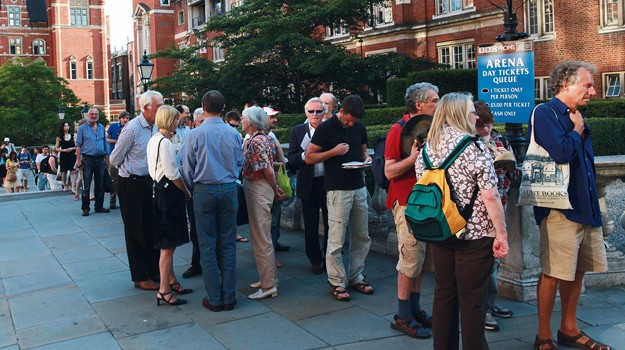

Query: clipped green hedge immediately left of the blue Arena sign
[[404, 69, 477, 96]]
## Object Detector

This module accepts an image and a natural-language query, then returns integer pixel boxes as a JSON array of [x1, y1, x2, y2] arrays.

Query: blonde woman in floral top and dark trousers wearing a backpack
[[415, 93, 508, 350]]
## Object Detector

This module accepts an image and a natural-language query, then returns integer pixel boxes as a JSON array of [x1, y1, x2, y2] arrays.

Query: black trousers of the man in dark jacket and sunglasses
[[302, 177, 328, 265]]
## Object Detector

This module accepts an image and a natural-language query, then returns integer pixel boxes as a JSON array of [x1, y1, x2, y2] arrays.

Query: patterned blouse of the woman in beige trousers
[[243, 132, 273, 180]]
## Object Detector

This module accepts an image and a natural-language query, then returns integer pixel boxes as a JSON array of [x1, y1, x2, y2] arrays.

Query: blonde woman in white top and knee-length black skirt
[[147, 105, 193, 305]]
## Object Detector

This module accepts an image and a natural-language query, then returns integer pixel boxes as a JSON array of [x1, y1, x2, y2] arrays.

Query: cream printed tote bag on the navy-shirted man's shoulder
[[518, 108, 573, 209]]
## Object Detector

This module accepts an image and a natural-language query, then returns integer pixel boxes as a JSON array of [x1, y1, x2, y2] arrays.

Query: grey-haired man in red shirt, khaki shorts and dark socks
[[384, 83, 438, 339]]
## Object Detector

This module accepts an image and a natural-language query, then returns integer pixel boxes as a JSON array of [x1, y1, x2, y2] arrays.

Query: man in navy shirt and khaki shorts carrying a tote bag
[[527, 61, 611, 350]]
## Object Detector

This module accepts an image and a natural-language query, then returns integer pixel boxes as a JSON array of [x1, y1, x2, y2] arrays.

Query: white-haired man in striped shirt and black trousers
[[111, 90, 163, 290]]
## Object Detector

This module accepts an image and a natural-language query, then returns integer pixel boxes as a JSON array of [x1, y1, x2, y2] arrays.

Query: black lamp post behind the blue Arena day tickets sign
[[491, 0, 529, 162]]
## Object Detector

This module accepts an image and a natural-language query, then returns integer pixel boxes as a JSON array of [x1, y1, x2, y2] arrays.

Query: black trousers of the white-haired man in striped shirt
[[117, 176, 160, 282]]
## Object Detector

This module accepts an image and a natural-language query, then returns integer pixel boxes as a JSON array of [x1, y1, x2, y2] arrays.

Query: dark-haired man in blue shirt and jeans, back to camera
[[182, 90, 243, 311]]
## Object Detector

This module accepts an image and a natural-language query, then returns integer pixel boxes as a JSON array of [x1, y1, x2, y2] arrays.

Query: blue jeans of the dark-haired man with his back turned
[[193, 182, 239, 306]]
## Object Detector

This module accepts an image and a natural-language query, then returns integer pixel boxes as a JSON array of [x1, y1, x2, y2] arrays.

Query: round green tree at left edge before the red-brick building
[[0, 58, 80, 145]]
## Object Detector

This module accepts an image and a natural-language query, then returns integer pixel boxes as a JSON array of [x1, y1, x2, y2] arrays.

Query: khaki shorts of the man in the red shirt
[[393, 201, 426, 278]]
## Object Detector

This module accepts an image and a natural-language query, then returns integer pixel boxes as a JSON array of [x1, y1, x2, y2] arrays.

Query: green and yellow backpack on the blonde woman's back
[[405, 135, 479, 242]]
